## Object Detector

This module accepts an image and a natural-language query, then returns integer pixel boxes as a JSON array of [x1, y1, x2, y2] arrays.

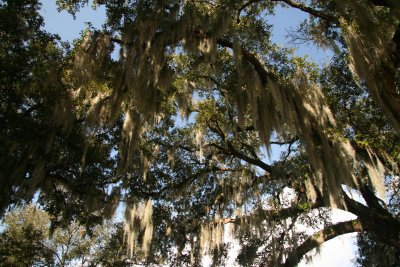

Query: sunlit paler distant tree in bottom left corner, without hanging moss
[[0, 204, 119, 266]]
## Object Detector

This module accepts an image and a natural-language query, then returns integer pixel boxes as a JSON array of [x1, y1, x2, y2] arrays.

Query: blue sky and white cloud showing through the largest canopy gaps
[[41, 0, 354, 267]]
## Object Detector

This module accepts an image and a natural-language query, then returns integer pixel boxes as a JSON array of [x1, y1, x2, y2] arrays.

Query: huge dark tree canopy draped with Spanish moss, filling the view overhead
[[0, 0, 400, 266]]
